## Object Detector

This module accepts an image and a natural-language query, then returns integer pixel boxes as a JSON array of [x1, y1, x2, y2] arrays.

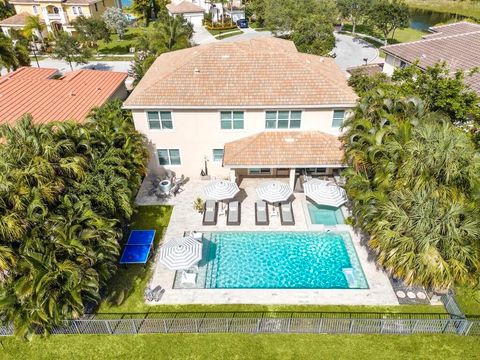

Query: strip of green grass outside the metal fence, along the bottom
[[0, 334, 480, 360]]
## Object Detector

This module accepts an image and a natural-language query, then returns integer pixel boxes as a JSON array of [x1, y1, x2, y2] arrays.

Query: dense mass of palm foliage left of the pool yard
[[0, 101, 147, 337]]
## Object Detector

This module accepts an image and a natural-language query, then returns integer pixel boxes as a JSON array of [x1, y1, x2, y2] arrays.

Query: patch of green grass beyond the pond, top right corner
[[406, 0, 480, 19]]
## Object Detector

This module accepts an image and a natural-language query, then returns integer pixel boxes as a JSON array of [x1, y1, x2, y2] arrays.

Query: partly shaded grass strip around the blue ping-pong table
[[100, 206, 172, 312]]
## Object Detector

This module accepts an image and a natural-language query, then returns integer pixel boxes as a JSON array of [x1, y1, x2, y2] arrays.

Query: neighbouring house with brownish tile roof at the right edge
[[382, 22, 480, 94]]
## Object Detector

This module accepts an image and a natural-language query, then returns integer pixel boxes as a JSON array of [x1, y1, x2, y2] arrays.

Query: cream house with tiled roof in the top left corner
[[0, 0, 121, 36]]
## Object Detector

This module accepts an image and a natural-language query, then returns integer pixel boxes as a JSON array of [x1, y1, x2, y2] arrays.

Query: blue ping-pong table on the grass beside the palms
[[120, 230, 155, 264]]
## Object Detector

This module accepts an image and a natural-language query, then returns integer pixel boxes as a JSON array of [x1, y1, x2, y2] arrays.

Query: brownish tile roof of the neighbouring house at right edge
[[382, 24, 480, 70]]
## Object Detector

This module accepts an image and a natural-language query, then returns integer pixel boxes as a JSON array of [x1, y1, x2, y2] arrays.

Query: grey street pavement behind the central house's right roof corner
[[332, 33, 378, 70]]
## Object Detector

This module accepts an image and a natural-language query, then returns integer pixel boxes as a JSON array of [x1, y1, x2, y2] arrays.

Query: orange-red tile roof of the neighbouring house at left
[[0, 67, 127, 124]]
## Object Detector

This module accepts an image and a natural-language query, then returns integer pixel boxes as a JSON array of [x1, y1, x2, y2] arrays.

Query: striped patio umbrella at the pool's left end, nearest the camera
[[158, 236, 203, 270]]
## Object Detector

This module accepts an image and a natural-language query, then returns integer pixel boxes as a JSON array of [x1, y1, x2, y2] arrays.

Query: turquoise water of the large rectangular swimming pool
[[202, 232, 368, 289]]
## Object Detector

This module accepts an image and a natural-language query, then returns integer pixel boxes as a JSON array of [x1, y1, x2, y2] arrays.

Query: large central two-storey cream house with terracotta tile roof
[[124, 38, 357, 186]]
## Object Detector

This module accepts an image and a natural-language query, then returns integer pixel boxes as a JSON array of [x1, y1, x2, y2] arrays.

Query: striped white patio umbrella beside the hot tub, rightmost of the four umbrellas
[[303, 179, 347, 207]]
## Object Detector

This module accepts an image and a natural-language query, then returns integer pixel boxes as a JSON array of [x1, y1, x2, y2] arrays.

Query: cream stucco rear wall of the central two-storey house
[[133, 108, 352, 178]]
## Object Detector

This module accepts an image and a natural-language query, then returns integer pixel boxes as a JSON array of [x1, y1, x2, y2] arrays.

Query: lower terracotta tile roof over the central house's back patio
[[223, 131, 343, 167]]
